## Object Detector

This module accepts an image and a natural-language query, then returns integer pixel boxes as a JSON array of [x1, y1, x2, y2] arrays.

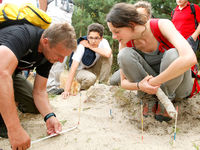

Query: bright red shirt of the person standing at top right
[[172, 2, 200, 39]]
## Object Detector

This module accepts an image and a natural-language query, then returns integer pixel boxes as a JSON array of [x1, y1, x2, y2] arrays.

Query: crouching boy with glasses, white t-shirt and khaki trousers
[[62, 23, 112, 98]]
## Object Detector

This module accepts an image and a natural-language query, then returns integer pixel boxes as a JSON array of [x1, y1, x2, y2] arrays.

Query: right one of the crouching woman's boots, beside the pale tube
[[155, 102, 172, 122]]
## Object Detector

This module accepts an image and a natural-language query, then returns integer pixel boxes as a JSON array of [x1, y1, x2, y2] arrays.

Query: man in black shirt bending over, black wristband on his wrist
[[0, 23, 76, 150]]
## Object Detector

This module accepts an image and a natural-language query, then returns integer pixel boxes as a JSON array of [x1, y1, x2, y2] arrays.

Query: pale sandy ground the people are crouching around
[[0, 70, 200, 150]]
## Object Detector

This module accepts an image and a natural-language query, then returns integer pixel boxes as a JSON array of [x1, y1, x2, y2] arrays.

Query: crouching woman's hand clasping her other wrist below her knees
[[138, 76, 160, 94]]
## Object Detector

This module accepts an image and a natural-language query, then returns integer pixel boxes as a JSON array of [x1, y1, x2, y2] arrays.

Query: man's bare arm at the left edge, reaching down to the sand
[[0, 46, 30, 150]]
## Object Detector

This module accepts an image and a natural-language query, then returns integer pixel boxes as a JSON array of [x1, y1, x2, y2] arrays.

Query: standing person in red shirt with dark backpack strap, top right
[[172, 0, 200, 53]]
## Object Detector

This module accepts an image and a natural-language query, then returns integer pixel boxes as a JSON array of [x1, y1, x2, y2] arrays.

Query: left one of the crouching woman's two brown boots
[[143, 101, 156, 117]]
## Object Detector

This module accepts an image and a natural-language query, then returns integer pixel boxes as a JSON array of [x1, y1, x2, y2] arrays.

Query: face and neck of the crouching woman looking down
[[107, 22, 141, 43]]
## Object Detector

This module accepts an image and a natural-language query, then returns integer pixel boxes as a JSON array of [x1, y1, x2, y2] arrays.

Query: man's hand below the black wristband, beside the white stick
[[46, 117, 62, 135]]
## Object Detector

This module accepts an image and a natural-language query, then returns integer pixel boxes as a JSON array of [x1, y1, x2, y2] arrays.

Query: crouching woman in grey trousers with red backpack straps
[[106, 3, 197, 121]]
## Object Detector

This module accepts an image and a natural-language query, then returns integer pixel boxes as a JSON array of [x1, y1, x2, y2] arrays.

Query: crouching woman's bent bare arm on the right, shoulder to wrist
[[149, 19, 197, 85]]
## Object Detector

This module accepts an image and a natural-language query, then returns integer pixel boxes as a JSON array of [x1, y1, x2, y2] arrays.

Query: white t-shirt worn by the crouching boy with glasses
[[72, 39, 111, 70]]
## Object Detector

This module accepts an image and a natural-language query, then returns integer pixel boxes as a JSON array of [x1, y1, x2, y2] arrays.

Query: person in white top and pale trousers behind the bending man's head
[[46, 0, 74, 95]]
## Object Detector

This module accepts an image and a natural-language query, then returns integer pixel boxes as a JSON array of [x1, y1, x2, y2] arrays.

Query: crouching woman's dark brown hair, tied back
[[106, 3, 147, 28]]
